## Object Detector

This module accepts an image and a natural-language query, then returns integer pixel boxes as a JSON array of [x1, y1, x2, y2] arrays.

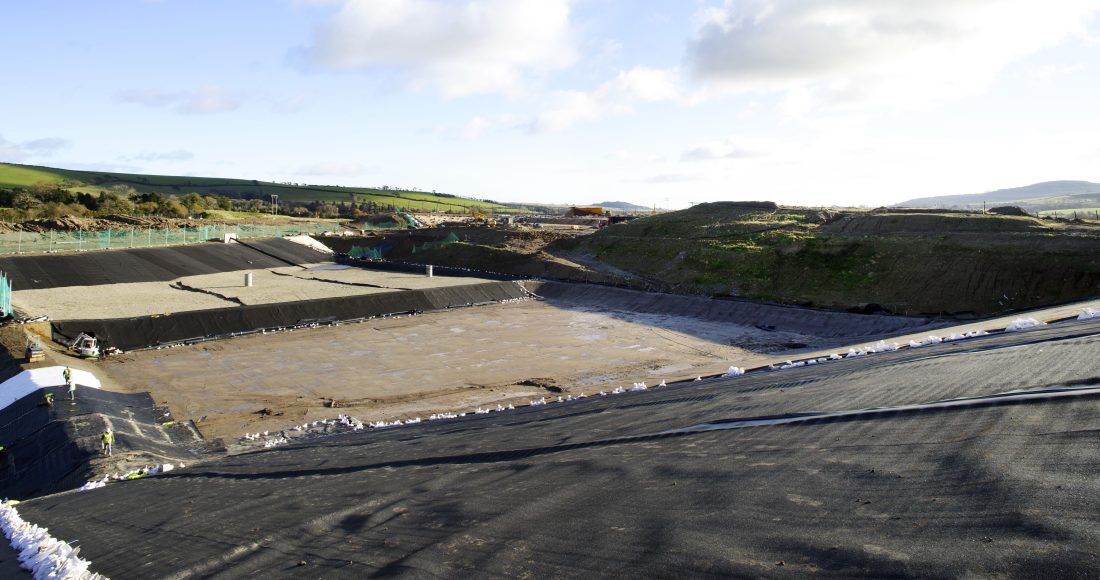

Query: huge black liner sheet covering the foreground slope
[[19, 321, 1100, 578]]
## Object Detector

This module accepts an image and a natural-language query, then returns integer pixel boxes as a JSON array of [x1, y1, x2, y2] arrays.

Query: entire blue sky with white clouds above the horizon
[[0, 0, 1100, 208]]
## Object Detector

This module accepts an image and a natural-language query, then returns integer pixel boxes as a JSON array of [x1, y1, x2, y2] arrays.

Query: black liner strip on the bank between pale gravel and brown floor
[[51, 282, 526, 350]]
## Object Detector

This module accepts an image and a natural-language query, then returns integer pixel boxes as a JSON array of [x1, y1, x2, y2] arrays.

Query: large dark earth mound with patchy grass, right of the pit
[[572, 204, 1100, 315]]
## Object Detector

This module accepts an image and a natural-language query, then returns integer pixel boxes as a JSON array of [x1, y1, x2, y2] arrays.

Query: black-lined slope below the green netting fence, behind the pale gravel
[[0, 238, 332, 292]]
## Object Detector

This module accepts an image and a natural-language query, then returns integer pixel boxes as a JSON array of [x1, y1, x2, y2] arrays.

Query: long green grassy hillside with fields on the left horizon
[[0, 163, 523, 214]]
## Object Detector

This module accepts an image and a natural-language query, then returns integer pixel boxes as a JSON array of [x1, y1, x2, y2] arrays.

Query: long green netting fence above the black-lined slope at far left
[[0, 222, 339, 254]]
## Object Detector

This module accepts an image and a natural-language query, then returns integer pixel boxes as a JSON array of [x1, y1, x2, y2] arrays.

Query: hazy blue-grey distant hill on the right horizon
[[897, 180, 1100, 212]]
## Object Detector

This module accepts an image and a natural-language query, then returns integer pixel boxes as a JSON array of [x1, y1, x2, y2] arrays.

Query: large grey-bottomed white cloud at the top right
[[685, 0, 1100, 108]]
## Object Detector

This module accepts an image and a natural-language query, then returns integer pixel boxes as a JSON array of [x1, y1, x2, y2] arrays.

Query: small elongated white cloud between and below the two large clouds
[[531, 66, 681, 133]]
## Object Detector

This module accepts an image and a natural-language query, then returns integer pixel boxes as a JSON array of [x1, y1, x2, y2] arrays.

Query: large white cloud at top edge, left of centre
[[301, 0, 576, 98]]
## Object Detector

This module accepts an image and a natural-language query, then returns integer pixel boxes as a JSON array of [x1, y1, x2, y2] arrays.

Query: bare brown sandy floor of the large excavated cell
[[98, 300, 814, 437]]
